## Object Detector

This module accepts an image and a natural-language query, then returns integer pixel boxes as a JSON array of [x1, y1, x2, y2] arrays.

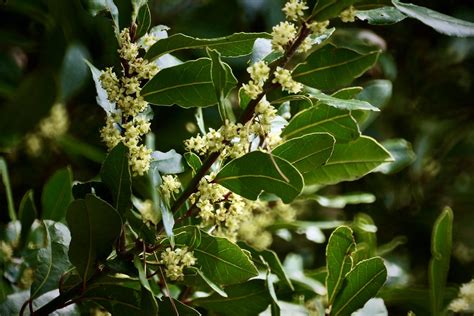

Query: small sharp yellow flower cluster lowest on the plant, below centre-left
[[160, 247, 196, 281]]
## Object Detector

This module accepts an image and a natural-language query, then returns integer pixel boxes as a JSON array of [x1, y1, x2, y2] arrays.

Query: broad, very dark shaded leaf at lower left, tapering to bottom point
[[66, 194, 122, 284]]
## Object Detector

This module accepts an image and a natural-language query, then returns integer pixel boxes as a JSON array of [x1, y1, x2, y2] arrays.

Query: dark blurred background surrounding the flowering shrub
[[0, 0, 474, 312]]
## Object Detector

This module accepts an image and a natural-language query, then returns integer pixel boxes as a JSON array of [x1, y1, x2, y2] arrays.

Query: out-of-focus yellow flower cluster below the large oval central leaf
[[238, 201, 296, 249]]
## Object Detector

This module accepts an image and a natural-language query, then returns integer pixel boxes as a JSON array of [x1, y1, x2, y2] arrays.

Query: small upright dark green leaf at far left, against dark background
[[41, 167, 72, 222]]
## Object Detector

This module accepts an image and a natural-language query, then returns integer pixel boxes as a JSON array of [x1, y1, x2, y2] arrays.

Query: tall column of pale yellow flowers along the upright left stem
[[100, 28, 158, 175]]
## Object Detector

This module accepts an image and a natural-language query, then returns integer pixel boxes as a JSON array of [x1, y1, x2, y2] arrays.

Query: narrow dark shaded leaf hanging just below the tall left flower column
[[100, 143, 132, 215]]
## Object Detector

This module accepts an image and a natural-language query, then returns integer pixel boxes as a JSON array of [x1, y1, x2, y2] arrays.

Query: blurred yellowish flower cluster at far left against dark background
[[25, 103, 69, 156]]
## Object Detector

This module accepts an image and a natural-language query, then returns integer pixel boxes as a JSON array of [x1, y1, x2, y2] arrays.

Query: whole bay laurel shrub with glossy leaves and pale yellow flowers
[[0, 0, 474, 315]]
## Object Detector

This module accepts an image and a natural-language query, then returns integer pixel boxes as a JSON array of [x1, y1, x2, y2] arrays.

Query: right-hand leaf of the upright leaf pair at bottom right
[[330, 257, 387, 316]]
